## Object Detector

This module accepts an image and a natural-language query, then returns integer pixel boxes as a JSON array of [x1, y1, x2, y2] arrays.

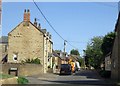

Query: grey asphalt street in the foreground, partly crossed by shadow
[[26, 70, 114, 86]]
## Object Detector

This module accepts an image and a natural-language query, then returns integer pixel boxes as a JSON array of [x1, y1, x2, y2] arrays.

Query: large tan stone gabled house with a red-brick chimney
[[8, 9, 53, 73]]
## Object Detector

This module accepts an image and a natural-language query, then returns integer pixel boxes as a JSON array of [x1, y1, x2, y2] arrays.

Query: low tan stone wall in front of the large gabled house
[[2, 63, 43, 76]]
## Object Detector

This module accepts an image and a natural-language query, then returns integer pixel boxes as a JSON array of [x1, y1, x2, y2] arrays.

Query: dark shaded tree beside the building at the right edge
[[101, 32, 116, 57]]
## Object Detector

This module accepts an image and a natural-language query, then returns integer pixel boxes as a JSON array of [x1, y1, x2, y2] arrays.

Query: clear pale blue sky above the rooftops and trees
[[2, 2, 118, 55]]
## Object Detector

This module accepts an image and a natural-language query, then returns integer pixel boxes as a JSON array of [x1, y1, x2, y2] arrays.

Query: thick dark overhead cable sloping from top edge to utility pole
[[33, 0, 78, 49]]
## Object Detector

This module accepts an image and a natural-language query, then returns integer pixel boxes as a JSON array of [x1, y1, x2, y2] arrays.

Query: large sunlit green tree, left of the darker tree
[[84, 36, 103, 69]]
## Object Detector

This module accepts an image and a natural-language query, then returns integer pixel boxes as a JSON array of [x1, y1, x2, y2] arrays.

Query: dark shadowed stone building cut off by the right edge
[[111, 12, 120, 81]]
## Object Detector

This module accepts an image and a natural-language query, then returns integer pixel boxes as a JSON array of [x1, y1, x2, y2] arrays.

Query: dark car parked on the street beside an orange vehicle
[[60, 64, 72, 75]]
